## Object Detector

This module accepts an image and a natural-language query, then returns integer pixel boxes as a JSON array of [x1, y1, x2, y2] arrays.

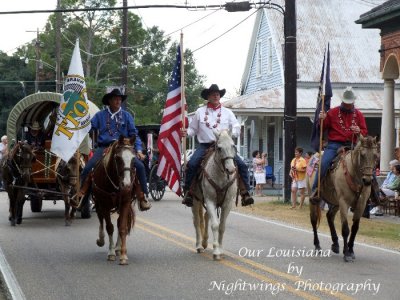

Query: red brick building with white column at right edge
[[356, 0, 400, 171]]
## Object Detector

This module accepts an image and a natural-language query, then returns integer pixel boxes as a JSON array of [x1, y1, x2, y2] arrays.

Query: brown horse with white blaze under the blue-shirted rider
[[92, 137, 135, 265]]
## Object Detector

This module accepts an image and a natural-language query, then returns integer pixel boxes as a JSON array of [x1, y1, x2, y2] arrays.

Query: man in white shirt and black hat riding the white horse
[[181, 84, 254, 207]]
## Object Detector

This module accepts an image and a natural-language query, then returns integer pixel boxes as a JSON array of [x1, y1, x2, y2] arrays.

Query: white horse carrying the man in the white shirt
[[192, 130, 238, 260]]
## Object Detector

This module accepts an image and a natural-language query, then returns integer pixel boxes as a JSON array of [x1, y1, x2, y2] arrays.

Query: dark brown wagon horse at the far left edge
[[1, 142, 36, 226]]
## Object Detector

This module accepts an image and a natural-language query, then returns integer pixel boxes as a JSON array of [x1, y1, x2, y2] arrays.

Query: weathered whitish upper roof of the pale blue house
[[242, 0, 382, 89]]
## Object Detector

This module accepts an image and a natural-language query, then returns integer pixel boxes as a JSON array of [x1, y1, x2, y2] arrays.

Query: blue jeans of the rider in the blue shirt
[[81, 147, 149, 196]]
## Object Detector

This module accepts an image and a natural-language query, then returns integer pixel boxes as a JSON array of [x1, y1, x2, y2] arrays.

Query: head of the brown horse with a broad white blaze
[[111, 136, 135, 190]]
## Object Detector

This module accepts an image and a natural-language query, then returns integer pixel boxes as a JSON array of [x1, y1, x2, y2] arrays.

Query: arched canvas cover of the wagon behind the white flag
[[7, 92, 99, 154]]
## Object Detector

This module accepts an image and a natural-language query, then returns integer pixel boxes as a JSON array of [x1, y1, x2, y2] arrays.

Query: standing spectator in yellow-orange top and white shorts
[[289, 147, 307, 209]]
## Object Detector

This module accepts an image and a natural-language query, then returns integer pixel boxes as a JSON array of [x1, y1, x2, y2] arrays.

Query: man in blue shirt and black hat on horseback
[[78, 89, 151, 211]]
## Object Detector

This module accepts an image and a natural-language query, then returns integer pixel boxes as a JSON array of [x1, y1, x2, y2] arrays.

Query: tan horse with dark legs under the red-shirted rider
[[309, 136, 377, 262]]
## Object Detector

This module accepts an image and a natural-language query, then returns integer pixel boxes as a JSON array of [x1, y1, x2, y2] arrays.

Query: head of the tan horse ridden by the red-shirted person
[[355, 135, 378, 185]]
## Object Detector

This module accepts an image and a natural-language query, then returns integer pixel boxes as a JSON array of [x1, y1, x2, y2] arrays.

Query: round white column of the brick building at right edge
[[380, 79, 395, 174]]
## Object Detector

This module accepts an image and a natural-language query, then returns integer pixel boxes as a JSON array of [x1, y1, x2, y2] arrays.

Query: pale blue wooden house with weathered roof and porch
[[224, 0, 400, 183]]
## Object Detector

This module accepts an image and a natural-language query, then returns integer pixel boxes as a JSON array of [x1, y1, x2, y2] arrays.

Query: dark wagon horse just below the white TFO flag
[[56, 155, 80, 226]]
